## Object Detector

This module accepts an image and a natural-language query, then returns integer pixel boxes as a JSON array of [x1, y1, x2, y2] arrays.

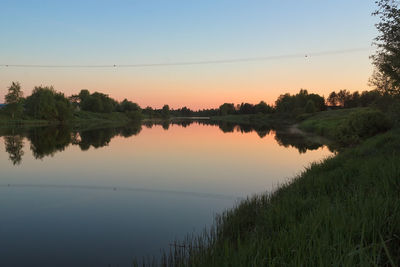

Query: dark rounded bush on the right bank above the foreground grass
[[335, 109, 392, 145]]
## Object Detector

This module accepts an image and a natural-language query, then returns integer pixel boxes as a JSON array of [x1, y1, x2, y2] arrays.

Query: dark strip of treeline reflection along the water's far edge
[[0, 119, 332, 166]]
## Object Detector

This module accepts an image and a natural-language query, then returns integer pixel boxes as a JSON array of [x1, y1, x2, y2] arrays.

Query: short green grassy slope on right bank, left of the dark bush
[[298, 108, 366, 139]]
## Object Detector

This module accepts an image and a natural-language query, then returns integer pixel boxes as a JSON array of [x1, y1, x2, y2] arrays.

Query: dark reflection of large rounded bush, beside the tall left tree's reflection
[[27, 126, 72, 159]]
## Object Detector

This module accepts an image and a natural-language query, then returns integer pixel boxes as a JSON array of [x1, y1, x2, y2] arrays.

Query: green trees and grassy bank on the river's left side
[[0, 86, 146, 127]]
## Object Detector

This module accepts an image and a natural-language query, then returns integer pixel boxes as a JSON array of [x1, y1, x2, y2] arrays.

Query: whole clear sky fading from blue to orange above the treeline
[[0, 0, 378, 109]]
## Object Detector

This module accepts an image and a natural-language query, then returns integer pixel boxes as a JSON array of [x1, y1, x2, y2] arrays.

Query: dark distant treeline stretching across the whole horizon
[[2, 82, 393, 122]]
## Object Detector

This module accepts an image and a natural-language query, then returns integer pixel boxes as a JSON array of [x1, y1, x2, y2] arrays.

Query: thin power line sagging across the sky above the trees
[[0, 48, 371, 68]]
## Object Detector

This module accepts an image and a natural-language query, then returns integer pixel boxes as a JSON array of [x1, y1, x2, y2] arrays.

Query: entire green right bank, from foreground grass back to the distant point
[[155, 87, 400, 266]]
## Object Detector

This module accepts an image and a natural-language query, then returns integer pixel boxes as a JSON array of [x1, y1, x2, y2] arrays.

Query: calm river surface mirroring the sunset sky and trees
[[0, 121, 331, 266]]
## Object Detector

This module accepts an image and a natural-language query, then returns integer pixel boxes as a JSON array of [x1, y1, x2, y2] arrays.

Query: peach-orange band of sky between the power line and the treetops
[[0, 53, 372, 110]]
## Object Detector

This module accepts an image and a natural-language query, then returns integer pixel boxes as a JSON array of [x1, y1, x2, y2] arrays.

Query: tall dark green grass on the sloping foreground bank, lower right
[[159, 129, 400, 266]]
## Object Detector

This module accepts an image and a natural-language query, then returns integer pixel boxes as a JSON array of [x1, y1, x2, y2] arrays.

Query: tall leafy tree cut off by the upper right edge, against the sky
[[372, 0, 400, 94]]
